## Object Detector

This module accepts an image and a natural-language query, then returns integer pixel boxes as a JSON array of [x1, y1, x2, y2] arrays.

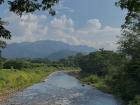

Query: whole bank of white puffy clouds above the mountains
[[5, 14, 120, 50]]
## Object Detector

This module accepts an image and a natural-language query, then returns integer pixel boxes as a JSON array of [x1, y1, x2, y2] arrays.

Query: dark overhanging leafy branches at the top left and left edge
[[0, 0, 59, 48]]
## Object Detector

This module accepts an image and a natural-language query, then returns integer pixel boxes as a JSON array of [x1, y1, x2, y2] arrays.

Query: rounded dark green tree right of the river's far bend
[[79, 50, 122, 76]]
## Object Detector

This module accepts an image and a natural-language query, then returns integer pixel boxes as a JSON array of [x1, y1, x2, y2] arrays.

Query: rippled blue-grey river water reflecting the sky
[[4, 72, 120, 105]]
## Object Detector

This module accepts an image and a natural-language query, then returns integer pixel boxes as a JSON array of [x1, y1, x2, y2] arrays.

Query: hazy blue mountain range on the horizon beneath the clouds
[[2, 40, 96, 59]]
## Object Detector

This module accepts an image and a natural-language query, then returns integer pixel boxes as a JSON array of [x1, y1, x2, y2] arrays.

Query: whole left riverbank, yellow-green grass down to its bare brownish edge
[[0, 66, 78, 105]]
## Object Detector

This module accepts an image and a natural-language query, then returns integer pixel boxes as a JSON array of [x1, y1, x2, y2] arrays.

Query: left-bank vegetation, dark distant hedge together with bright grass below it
[[0, 58, 78, 95]]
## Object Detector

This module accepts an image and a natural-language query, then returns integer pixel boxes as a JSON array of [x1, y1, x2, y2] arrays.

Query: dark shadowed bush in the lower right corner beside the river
[[107, 60, 140, 102]]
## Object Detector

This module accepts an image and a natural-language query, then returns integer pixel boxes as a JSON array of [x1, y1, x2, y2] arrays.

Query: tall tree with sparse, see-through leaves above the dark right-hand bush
[[116, 0, 140, 58]]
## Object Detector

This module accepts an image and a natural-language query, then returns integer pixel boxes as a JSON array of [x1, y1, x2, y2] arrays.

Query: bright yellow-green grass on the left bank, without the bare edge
[[0, 67, 56, 94]]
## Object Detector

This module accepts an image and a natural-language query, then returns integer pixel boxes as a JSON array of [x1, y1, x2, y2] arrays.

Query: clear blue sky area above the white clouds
[[54, 0, 123, 27]]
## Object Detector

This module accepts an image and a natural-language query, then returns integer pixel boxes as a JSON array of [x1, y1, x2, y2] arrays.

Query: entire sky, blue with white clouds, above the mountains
[[0, 0, 125, 50]]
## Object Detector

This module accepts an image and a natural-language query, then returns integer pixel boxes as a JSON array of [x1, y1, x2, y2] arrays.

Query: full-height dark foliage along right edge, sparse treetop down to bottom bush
[[107, 0, 140, 105]]
